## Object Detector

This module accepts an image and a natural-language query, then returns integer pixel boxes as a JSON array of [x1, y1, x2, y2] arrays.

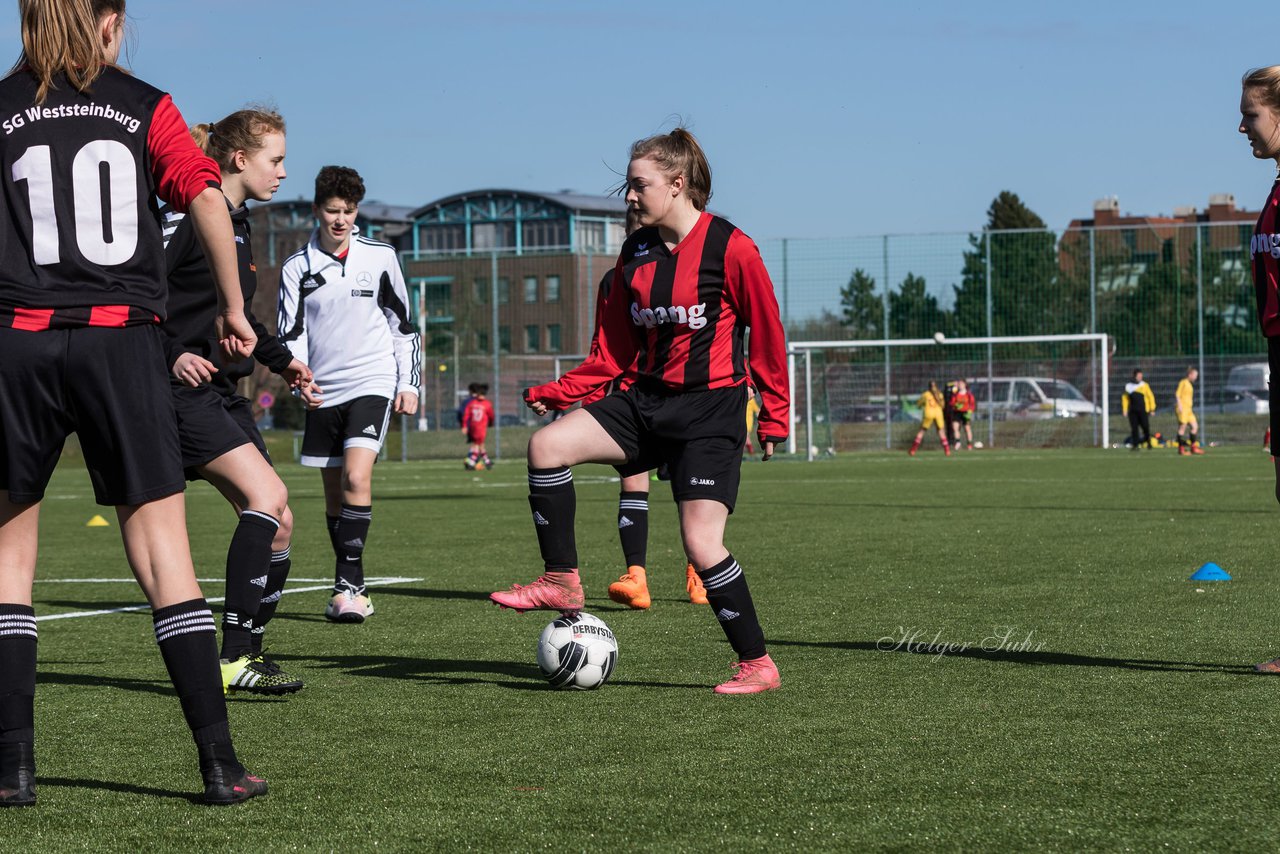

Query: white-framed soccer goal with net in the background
[[787, 333, 1111, 460]]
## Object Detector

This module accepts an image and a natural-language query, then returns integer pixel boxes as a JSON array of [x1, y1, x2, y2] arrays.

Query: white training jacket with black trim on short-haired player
[[278, 229, 421, 408]]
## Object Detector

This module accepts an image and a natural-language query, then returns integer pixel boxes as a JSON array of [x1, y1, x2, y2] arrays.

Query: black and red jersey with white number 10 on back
[[0, 68, 220, 330]]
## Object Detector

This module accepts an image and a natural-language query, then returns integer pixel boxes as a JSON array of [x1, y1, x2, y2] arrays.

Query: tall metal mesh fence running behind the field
[[256, 222, 1267, 457]]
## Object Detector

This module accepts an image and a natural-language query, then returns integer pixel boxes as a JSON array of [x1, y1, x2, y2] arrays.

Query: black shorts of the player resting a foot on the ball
[[585, 385, 746, 513]]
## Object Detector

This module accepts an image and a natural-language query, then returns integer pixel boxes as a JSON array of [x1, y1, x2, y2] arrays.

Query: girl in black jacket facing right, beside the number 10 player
[[160, 108, 315, 695]]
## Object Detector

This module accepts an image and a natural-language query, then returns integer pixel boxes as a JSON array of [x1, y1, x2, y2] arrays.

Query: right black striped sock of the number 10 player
[[151, 599, 236, 764]]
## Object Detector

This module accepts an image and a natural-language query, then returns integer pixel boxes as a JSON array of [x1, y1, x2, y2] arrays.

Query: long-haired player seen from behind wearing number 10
[[0, 0, 266, 805]]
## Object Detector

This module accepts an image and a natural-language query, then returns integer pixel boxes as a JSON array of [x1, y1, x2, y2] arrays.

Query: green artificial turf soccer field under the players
[[0, 448, 1280, 851]]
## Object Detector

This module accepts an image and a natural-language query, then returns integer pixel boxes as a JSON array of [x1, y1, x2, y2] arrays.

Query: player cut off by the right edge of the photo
[[1239, 65, 1280, 673]]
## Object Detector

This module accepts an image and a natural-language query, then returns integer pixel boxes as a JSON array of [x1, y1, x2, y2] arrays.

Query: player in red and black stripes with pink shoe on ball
[[492, 128, 790, 694]]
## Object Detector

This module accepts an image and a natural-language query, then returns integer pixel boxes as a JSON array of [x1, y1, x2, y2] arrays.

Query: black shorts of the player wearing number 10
[[0, 325, 186, 506]]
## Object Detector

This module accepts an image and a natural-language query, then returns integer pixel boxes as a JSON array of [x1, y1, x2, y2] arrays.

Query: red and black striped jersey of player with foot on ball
[[526, 213, 790, 440]]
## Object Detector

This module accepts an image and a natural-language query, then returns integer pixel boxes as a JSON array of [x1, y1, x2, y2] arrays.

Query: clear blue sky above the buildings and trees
[[0, 0, 1280, 239]]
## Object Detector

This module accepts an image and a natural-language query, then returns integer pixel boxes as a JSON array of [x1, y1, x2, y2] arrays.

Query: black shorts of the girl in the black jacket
[[169, 384, 271, 480]]
